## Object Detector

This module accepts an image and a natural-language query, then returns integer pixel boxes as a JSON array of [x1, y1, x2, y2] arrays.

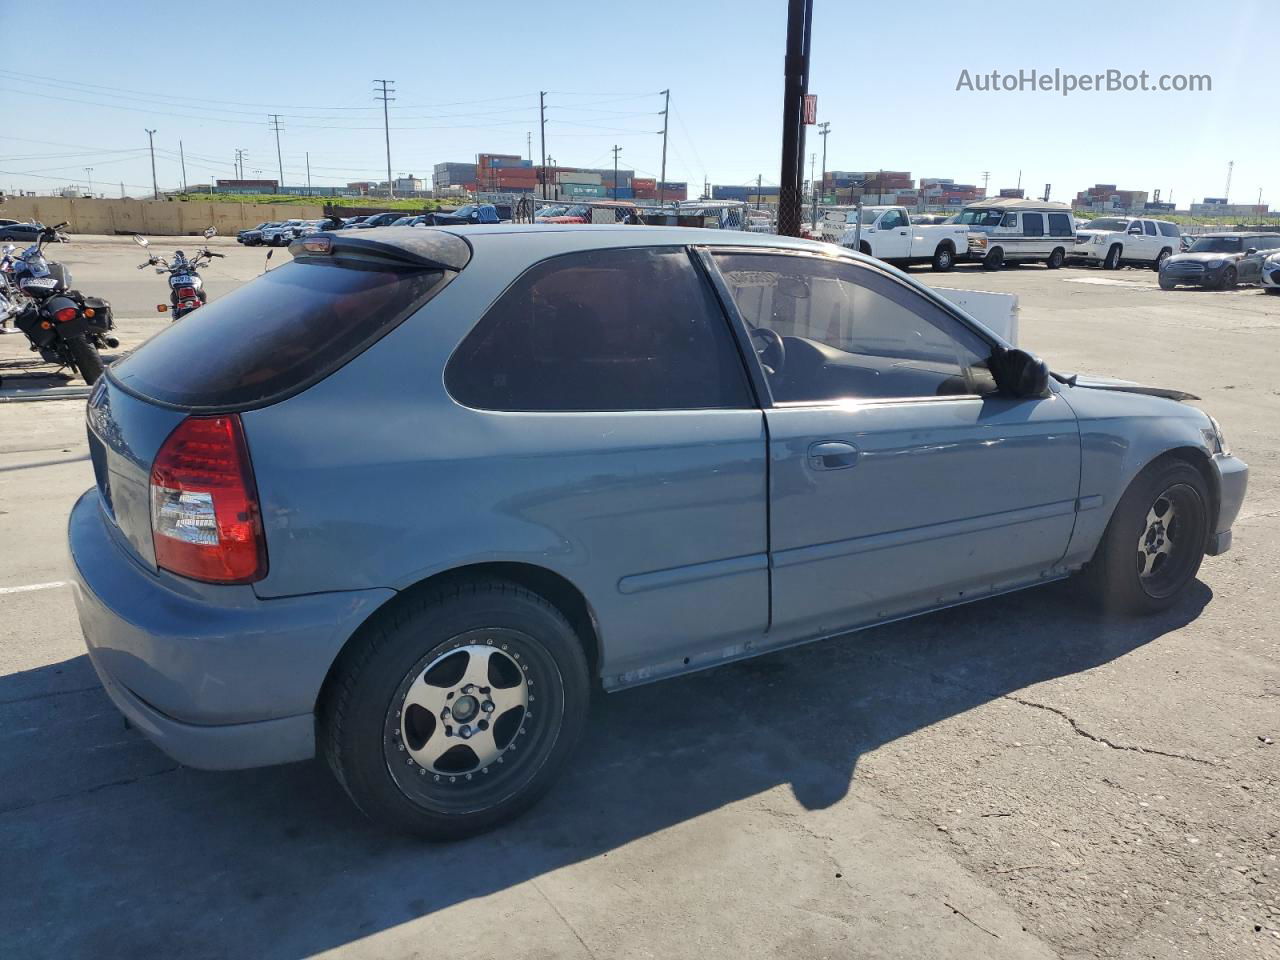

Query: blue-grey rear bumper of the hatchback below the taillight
[[68, 490, 394, 769]]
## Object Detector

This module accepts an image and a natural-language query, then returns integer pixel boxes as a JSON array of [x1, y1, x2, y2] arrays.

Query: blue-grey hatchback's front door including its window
[[713, 250, 1080, 636]]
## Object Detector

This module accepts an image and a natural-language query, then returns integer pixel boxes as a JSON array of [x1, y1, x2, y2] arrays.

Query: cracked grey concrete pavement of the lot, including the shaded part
[[0, 239, 1280, 960]]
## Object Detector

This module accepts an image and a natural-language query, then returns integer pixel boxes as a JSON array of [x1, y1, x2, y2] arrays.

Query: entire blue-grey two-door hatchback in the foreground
[[69, 225, 1247, 837]]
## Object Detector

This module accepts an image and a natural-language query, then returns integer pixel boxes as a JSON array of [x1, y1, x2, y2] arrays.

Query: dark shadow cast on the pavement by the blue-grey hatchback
[[0, 582, 1212, 957]]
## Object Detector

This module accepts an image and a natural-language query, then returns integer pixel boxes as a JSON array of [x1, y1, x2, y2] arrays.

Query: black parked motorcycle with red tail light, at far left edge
[[10, 223, 120, 384]]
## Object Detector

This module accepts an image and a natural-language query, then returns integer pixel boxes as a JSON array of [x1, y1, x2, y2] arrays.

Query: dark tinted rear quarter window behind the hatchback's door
[[444, 247, 755, 411]]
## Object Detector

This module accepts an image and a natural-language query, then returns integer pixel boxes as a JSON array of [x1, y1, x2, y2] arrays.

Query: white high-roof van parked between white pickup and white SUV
[[955, 197, 1075, 270]]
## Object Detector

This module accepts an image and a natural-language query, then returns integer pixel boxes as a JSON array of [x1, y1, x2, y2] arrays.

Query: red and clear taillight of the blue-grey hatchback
[[151, 413, 266, 584]]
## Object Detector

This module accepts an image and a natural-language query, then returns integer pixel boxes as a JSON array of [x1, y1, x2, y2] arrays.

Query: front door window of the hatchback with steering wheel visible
[[716, 253, 996, 402]]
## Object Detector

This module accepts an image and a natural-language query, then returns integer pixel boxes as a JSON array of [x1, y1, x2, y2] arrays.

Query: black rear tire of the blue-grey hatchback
[[317, 580, 590, 840]]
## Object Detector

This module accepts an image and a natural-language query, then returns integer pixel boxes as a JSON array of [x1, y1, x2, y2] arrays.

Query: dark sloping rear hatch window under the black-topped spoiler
[[110, 257, 454, 411]]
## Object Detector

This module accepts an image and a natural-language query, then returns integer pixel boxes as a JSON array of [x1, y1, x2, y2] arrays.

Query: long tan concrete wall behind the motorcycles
[[0, 197, 324, 237]]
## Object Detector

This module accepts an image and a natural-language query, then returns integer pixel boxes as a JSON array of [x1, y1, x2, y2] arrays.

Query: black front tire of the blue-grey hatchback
[[1087, 458, 1210, 614]]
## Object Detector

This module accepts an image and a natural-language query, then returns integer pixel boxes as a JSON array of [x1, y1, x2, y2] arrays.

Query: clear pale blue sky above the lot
[[0, 0, 1280, 206]]
